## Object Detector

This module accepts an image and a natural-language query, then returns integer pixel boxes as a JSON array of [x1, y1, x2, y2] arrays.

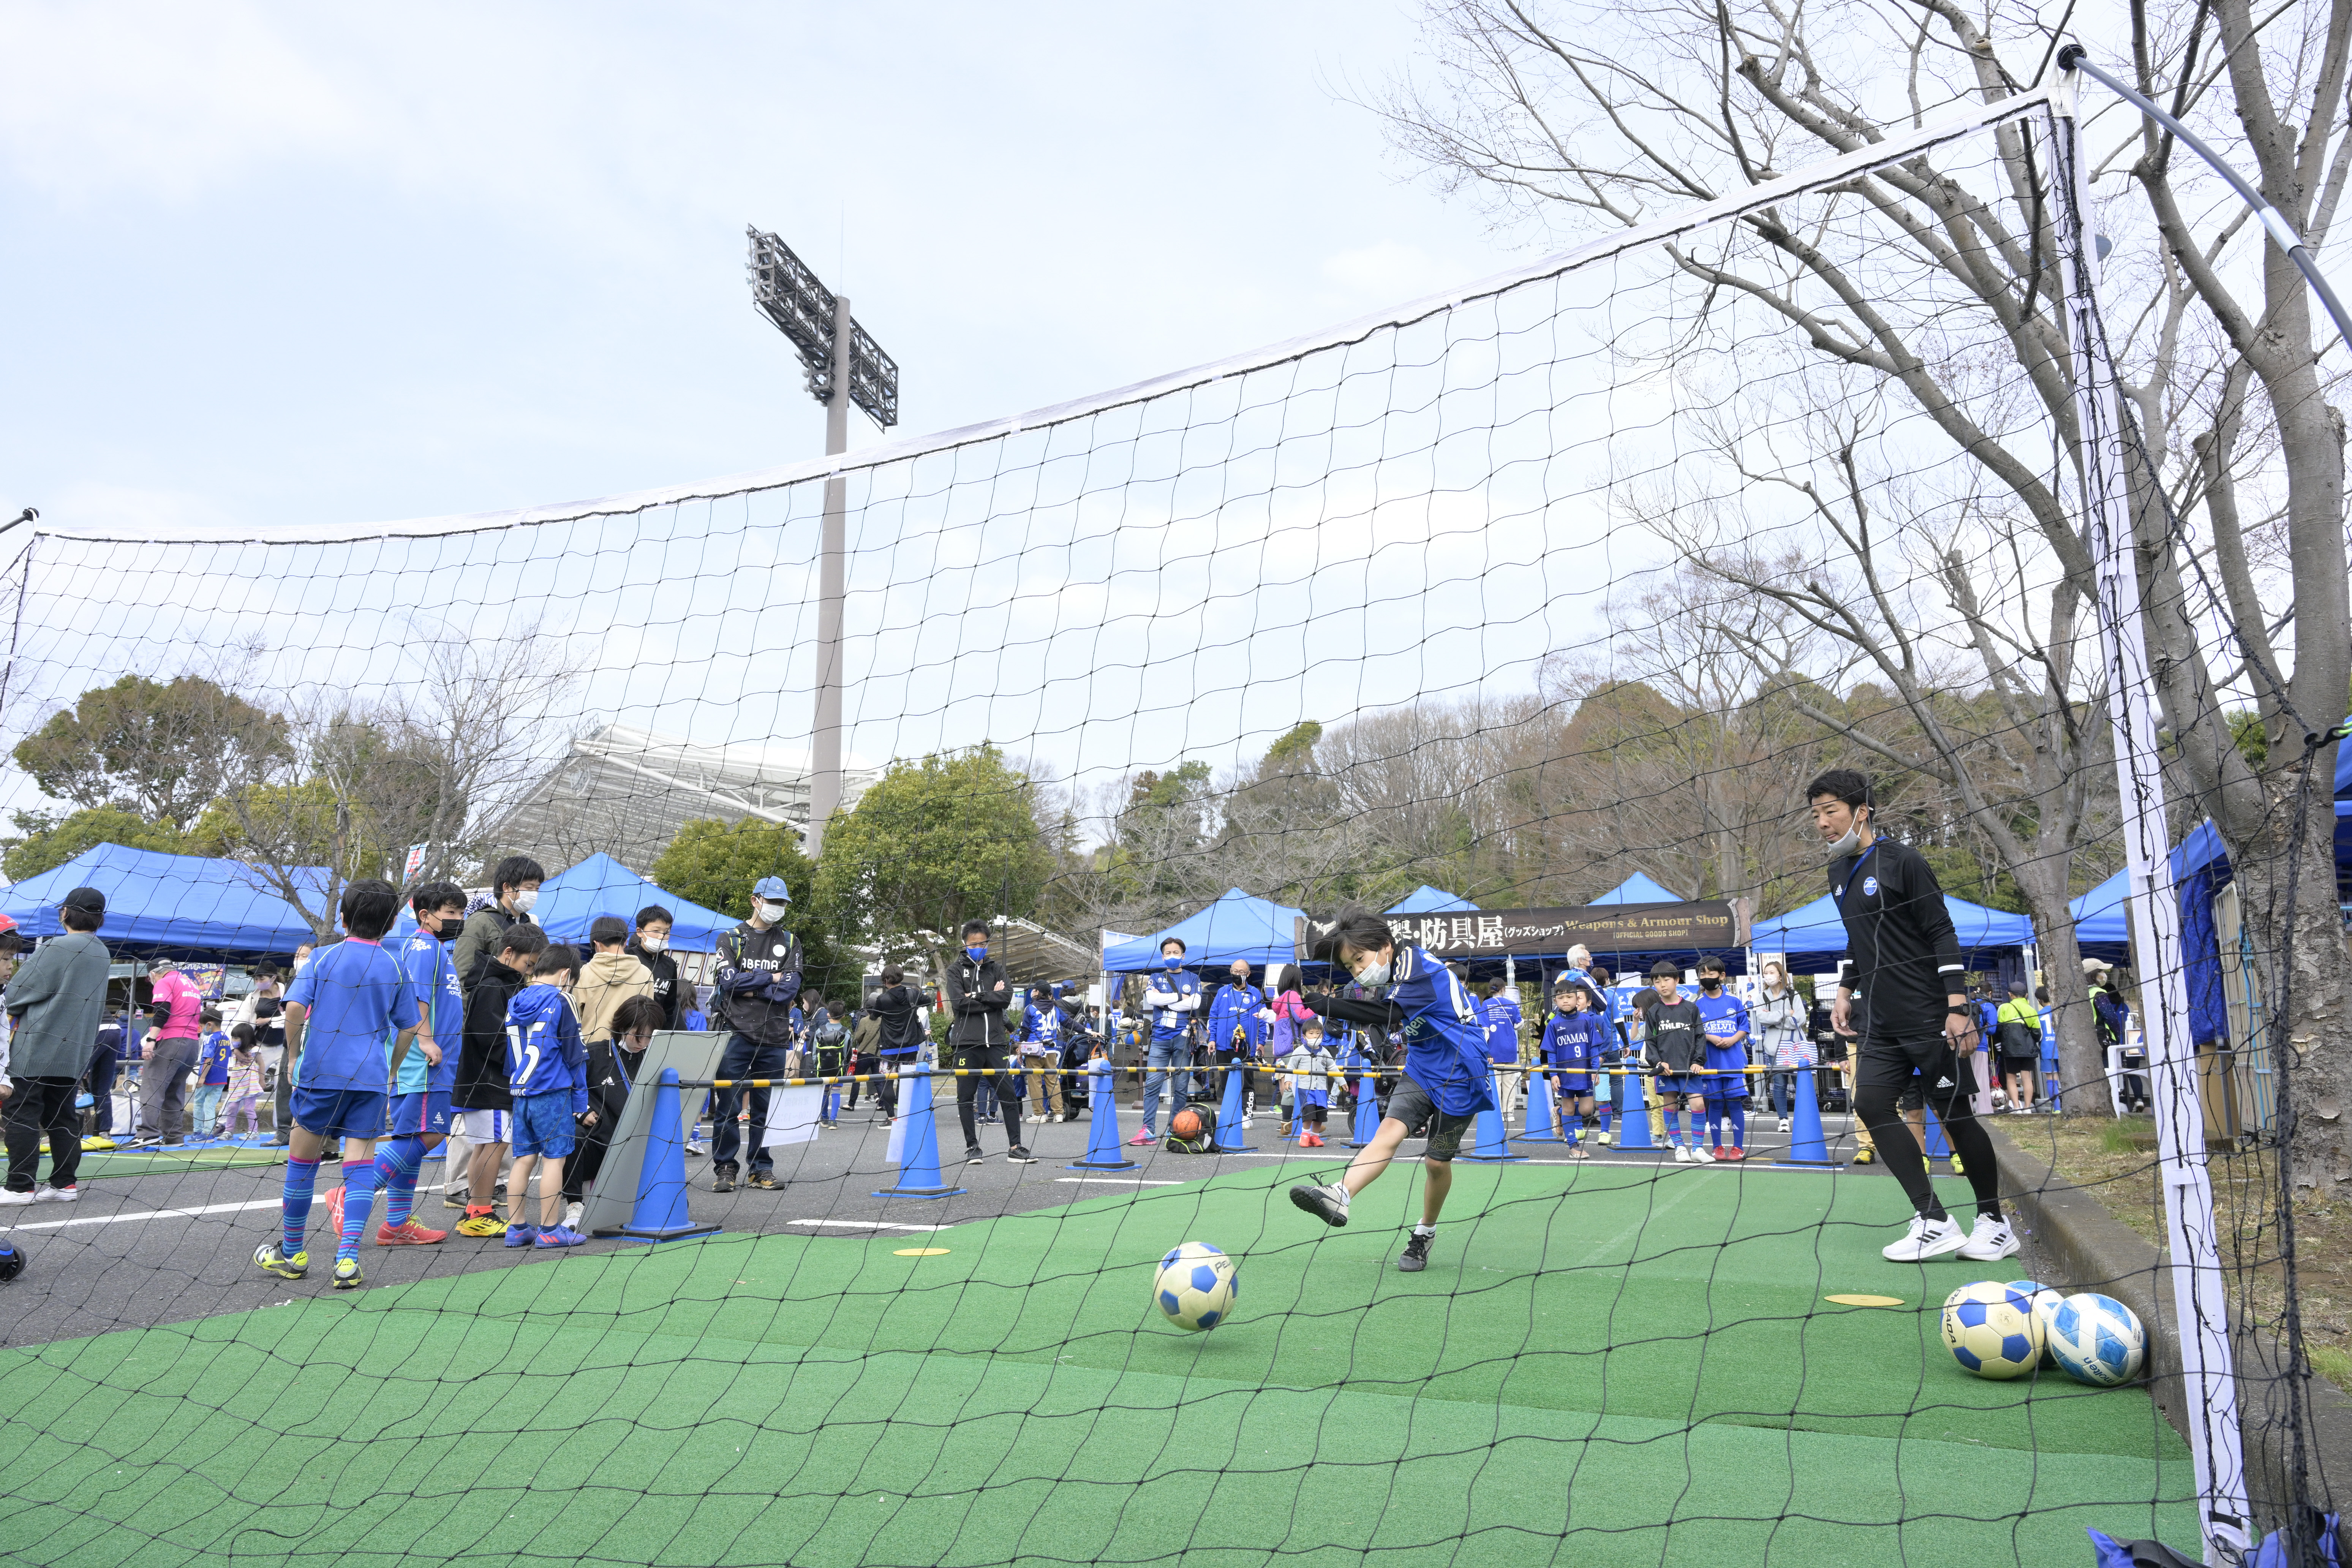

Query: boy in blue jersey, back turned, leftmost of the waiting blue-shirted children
[[254, 877, 423, 1291]]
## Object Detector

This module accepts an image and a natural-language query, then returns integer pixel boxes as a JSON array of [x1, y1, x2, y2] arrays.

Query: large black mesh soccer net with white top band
[[0, 80, 2345, 1566]]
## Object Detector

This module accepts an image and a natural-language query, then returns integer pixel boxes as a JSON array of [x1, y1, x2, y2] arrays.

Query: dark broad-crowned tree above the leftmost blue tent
[[12, 675, 292, 830]]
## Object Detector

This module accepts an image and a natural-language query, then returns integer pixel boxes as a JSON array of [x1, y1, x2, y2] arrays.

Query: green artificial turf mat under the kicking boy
[[0, 1166, 2194, 1568]]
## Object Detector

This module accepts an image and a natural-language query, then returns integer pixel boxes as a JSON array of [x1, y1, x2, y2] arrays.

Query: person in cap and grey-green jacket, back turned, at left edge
[[0, 888, 113, 1204]]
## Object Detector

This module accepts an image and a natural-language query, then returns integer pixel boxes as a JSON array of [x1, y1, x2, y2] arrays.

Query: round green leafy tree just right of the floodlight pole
[[816, 745, 1054, 973]]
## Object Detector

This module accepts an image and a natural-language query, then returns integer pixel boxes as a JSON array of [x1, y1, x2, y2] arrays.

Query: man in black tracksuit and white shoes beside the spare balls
[[1804, 769, 2018, 1262]]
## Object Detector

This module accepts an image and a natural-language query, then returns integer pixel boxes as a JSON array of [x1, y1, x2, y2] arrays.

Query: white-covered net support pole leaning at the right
[[2051, 75, 2251, 1563]]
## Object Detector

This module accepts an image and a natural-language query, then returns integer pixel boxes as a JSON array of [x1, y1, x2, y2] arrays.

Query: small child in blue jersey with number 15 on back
[[506, 945, 595, 1248]]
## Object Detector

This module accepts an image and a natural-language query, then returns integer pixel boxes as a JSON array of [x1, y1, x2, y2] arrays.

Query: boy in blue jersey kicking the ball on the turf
[[1291, 910, 1494, 1274]]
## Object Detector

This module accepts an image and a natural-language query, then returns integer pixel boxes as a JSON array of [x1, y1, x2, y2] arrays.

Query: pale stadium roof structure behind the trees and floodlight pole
[[485, 724, 880, 865]]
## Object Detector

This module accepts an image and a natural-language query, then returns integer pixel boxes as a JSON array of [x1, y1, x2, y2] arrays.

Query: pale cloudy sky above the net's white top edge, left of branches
[[0, 0, 1522, 531]]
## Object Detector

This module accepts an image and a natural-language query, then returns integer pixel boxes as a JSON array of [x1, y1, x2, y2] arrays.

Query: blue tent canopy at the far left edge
[[0, 844, 327, 959]]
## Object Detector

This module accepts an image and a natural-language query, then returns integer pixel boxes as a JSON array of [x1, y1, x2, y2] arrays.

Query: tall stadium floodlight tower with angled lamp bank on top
[[743, 228, 898, 858]]
